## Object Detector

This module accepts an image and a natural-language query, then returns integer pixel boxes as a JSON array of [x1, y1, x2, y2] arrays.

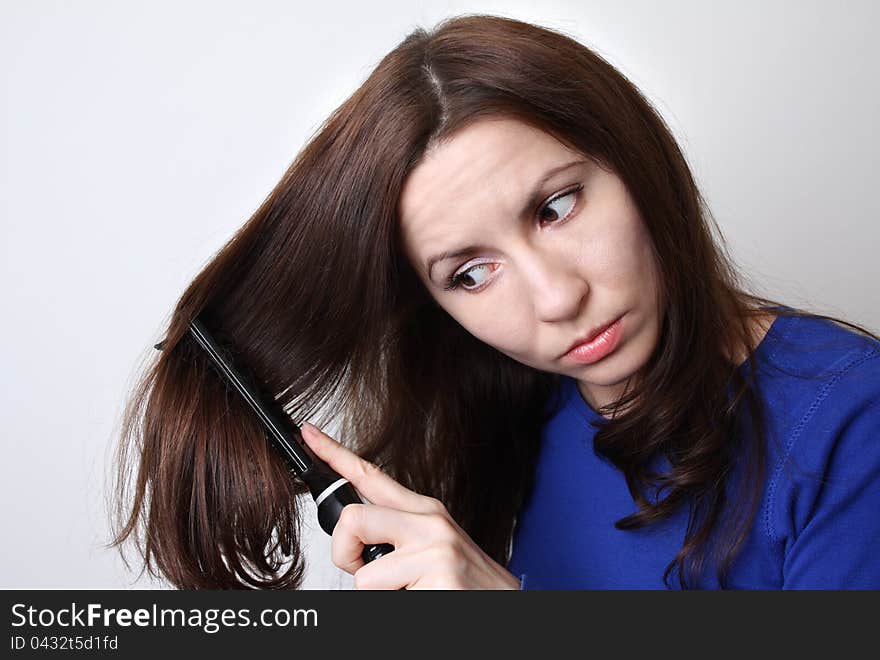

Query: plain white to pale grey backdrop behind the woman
[[0, 0, 880, 588]]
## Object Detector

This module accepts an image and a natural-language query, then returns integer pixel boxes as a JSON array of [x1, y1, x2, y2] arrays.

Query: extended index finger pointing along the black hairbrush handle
[[301, 422, 433, 512]]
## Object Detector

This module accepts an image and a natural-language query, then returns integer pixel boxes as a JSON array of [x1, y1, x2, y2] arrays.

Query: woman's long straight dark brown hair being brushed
[[112, 15, 873, 589]]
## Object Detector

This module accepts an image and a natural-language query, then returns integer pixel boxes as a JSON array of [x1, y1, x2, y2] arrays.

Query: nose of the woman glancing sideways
[[525, 253, 590, 323]]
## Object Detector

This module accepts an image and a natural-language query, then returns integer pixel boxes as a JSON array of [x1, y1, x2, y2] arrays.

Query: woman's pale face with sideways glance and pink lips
[[399, 118, 660, 408]]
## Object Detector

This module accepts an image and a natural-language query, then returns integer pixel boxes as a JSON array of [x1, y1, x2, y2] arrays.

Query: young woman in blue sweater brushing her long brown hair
[[108, 16, 880, 589]]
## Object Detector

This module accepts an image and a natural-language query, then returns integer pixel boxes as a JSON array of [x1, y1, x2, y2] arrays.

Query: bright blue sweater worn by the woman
[[508, 316, 880, 589]]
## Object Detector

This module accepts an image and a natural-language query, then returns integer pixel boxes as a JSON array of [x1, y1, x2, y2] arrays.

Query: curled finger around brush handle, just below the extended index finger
[[330, 504, 424, 573]]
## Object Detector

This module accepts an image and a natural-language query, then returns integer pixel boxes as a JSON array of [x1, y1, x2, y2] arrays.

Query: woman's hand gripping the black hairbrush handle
[[301, 423, 519, 589]]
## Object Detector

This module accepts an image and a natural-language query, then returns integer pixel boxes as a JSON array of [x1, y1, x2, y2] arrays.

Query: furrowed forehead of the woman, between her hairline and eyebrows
[[398, 118, 578, 273]]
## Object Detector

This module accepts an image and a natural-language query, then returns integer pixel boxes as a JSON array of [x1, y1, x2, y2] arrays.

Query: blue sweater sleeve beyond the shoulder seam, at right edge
[[783, 351, 880, 589]]
